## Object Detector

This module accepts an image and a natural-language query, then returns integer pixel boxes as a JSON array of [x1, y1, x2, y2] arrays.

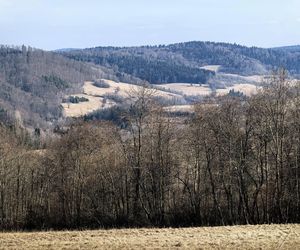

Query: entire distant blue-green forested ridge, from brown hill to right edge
[[63, 42, 300, 80]]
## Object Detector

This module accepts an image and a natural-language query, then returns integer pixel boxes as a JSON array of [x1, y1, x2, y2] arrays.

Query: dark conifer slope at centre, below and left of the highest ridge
[[65, 47, 214, 84]]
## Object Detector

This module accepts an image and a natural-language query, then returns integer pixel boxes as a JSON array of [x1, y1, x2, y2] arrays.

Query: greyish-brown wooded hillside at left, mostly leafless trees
[[0, 46, 101, 127]]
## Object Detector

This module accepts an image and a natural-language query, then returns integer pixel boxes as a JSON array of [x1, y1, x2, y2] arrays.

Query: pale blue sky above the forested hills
[[0, 0, 300, 50]]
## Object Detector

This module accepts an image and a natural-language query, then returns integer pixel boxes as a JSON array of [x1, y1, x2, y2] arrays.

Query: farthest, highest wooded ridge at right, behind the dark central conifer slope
[[166, 42, 300, 75]]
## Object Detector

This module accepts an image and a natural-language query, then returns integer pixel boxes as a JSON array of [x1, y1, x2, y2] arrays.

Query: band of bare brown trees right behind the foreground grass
[[0, 72, 300, 229]]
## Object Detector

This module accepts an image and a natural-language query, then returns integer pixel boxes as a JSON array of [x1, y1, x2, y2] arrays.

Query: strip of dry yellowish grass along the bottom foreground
[[0, 224, 300, 250]]
